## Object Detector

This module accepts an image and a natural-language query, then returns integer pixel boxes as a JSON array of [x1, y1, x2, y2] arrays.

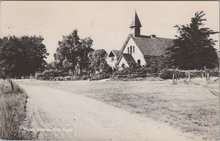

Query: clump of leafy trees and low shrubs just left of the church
[[35, 30, 112, 80]]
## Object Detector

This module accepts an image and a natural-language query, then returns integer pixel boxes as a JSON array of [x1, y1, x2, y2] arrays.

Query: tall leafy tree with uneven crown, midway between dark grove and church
[[54, 30, 93, 75]]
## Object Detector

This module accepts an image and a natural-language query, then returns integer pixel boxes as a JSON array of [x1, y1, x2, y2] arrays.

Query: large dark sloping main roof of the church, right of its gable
[[130, 35, 173, 56]]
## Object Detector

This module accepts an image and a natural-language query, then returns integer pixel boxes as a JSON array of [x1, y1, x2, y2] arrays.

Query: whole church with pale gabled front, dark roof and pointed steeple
[[106, 11, 173, 69]]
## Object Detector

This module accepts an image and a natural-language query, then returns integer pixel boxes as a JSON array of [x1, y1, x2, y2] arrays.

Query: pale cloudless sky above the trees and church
[[0, 1, 219, 62]]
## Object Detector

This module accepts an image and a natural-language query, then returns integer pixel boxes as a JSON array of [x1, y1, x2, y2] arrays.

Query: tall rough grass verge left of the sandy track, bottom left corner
[[0, 80, 32, 140]]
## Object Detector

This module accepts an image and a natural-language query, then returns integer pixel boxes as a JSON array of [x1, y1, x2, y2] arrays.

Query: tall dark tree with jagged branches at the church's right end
[[165, 11, 218, 69]]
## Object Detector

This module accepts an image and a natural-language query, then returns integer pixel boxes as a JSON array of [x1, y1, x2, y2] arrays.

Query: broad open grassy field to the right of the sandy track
[[15, 78, 219, 141]]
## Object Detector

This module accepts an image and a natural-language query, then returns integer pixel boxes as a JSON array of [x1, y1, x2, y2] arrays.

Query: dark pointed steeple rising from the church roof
[[130, 11, 142, 37]]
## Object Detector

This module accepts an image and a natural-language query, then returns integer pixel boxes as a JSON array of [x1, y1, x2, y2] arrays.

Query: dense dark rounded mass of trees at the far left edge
[[0, 36, 48, 78]]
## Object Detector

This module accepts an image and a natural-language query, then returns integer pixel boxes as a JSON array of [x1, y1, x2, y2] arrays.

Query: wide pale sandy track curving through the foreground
[[20, 84, 201, 141]]
